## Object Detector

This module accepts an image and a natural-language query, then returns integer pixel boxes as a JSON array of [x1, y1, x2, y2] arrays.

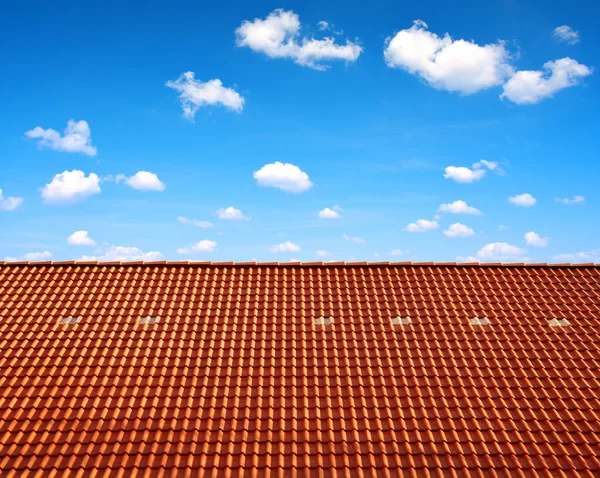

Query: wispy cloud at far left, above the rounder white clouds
[[25, 120, 98, 156]]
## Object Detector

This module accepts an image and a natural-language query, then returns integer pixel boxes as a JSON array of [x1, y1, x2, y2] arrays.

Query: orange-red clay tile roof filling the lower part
[[0, 263, 600, 477]]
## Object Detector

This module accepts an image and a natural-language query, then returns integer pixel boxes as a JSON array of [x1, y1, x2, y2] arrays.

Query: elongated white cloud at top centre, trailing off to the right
[[235, 9, 362, 70]]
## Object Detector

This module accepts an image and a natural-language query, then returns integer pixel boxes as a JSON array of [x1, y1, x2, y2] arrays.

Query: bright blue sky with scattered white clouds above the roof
[[0, 0, 600, 262]]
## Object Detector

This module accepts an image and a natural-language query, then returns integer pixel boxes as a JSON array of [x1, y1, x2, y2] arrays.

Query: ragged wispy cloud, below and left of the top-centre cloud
[[166, 71, 245, 121]]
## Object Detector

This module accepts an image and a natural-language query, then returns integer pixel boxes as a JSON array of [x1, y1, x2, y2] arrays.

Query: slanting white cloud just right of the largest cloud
[[500, 58, 592, 105]]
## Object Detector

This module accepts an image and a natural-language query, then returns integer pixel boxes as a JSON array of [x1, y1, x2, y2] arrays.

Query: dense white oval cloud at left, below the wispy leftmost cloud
[[40, 169, 101, 204]]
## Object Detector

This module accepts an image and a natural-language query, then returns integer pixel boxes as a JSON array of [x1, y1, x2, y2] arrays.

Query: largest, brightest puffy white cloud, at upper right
[[384, 20, 513, 95]]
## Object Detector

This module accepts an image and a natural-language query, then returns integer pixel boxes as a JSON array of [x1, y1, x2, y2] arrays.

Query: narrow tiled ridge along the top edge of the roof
[[0, 261, 600, 267]]
